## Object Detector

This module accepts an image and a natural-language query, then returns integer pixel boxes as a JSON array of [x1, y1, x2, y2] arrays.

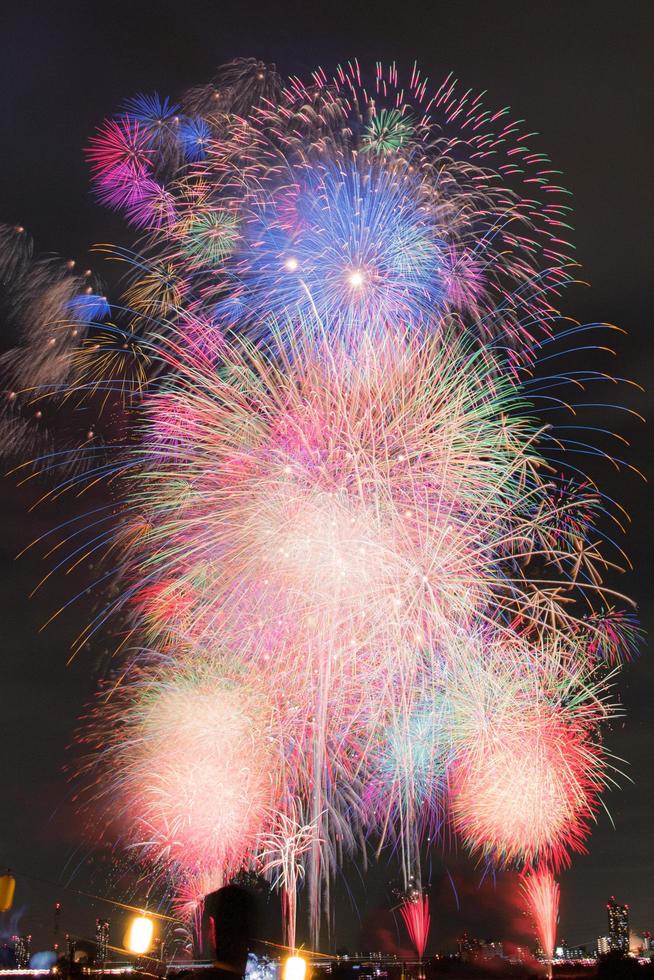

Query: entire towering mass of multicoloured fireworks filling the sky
[[0, 60, 638, 955]]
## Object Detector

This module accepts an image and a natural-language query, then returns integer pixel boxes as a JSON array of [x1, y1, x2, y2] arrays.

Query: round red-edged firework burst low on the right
[[449, 638, 615, 867]]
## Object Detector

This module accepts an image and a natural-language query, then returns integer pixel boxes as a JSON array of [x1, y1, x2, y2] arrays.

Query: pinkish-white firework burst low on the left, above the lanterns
[[81, 656, 276, 916]]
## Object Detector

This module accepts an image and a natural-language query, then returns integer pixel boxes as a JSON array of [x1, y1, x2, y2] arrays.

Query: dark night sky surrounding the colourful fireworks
[[0, 0, 654, 947]]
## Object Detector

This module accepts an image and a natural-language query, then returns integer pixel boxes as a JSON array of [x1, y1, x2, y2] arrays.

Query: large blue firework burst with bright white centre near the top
[[218, 157, 454, 338]]
